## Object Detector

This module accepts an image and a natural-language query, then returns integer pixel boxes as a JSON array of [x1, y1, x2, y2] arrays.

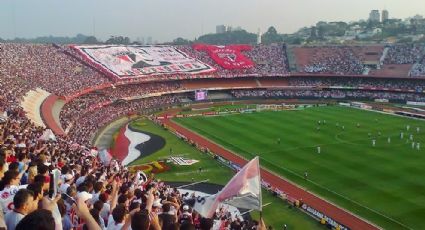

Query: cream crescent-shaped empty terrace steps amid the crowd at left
[[21, 88, 50, 128]]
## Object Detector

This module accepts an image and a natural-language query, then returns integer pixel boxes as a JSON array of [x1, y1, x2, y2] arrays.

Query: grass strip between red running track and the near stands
[[130, 119, 325, 230]]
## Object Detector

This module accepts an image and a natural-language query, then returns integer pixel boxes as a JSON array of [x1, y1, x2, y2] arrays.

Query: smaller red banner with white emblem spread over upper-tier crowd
[[193, 44, 254, 69]]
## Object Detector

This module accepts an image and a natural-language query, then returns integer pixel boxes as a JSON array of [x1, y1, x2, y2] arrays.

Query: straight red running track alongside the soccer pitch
[[163, 119, 379, 230]]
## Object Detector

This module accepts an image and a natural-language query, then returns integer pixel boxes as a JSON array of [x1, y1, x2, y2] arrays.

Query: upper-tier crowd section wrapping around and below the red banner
[[177, 44, 289, 78]]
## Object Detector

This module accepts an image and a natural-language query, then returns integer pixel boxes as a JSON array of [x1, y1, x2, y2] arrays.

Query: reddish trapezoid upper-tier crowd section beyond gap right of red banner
[[303, 46, 365, 75]]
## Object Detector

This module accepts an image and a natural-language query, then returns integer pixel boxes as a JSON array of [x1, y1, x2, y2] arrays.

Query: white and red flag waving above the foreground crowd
[[193, 157, 262, 218]]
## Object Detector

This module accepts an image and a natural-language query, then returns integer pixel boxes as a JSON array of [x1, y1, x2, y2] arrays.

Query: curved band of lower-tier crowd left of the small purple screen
[[60, 82, 181, 129]]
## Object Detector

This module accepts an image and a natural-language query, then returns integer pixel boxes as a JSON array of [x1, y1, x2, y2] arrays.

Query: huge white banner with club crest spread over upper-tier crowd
[[73, 45, 215, 79]]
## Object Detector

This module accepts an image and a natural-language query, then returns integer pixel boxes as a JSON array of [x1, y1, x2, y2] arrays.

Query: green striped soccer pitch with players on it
[[174, 106, 425, 229]]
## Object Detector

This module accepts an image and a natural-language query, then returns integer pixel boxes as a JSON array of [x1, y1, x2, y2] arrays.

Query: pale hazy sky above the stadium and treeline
[[0, 0, 425, 42]]
